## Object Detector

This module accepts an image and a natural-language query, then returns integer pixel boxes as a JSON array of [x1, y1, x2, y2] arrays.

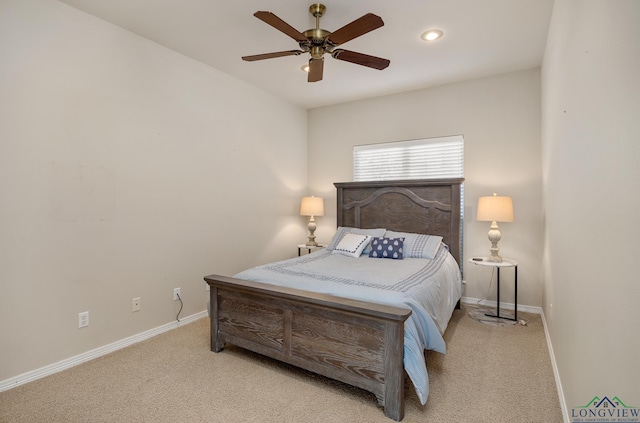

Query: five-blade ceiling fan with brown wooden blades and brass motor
[[242, 3, 391, 82]]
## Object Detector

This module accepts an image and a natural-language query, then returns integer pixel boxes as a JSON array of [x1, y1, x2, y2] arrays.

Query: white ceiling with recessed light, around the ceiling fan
[[60, 0, 553, 108]]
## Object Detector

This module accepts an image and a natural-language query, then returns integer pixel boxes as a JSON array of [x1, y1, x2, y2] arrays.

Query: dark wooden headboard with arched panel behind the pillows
[[334, 178, 464, 264]]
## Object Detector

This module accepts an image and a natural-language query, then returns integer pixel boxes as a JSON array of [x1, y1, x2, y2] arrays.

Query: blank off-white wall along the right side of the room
[[542, 0, 640, 413]]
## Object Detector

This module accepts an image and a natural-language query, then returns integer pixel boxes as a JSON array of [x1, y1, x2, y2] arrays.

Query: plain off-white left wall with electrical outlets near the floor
[[0, 0, 306, 380]]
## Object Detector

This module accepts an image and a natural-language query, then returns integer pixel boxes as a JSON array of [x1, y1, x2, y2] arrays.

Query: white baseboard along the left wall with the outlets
[[0, 310, 208, 392]]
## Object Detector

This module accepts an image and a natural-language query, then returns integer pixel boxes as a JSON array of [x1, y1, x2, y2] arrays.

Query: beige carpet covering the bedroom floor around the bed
[[0, 308, 562, 423]]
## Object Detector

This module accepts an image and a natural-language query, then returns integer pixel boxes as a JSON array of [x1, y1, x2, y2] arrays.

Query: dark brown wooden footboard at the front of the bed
[[204, 275, 411, 421]]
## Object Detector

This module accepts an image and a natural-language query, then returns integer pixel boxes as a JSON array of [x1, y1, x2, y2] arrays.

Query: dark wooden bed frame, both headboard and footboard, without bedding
[[204, 179, 463, 421]]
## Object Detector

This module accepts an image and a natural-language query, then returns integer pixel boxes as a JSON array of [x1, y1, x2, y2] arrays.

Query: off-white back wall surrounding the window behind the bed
[[308, 69, 542, 307]]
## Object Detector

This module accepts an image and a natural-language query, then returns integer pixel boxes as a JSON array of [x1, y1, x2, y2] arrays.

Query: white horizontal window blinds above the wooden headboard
[[353, 135, 464, 181]]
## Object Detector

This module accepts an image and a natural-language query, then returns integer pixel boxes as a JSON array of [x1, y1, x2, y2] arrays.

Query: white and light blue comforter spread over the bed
[[235, 245, 462, 404]]
